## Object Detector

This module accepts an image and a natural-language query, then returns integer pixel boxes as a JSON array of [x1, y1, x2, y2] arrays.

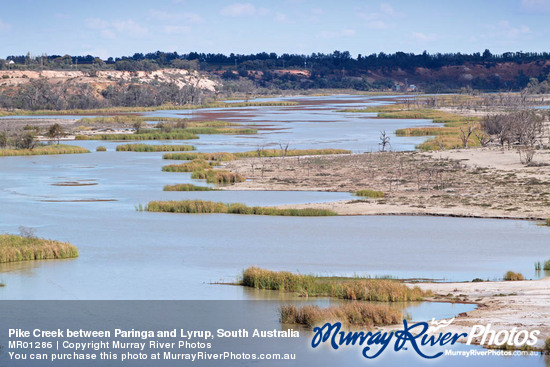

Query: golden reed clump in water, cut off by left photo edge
[[0, 234, 78, 263]]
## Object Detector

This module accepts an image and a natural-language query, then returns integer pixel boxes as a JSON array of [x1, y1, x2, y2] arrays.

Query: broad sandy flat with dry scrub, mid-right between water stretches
[[225, 149, 550, 219]]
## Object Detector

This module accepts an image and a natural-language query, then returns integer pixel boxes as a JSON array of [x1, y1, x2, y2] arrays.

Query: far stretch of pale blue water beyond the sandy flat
[[140, 96, 431, 153]]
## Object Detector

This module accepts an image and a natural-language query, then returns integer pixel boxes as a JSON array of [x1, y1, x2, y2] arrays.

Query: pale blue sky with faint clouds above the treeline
[[0, 0, 550, 58]]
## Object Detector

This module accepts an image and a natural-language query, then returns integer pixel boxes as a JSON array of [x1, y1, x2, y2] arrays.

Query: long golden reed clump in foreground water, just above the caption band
[[241, 267, 431, 302]]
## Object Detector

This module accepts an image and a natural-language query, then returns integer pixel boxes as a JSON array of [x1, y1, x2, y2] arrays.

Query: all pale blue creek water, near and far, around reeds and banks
[[0, 96, 550, 363]]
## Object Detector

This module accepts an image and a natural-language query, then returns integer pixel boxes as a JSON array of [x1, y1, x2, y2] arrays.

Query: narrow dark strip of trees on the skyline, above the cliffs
[[6, 50, 550, 72]]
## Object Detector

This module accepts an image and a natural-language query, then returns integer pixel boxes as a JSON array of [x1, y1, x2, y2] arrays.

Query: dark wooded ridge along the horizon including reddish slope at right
[[0, 50, 550, 92]]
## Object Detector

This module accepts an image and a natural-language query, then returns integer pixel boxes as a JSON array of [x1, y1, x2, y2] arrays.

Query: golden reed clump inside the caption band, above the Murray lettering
[[280, 302, 403, 328]]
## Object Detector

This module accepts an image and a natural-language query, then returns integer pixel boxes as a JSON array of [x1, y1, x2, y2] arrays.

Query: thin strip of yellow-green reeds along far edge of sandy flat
[[162, 149, 351, 161]]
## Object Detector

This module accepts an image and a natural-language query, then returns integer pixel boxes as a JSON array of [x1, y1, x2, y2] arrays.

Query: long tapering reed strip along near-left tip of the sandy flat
[[145, 200, 336, 217]]
